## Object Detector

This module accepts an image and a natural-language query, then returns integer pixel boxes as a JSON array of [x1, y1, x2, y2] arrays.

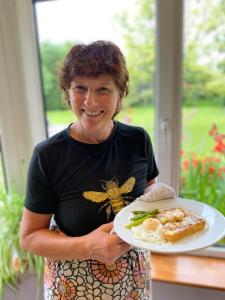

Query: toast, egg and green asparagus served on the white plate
[[126, 208, 206, 244]]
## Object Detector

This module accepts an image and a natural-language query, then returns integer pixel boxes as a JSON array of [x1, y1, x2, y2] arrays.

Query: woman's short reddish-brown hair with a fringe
[[60, 41, 129, 104]]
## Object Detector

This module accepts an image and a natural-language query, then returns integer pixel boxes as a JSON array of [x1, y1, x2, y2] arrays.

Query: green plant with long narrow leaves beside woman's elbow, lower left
[[0, 189, 44, 298]]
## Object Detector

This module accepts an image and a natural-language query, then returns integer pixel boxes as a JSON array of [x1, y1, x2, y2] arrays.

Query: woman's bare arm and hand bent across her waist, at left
[[20, 208, 131, 264]]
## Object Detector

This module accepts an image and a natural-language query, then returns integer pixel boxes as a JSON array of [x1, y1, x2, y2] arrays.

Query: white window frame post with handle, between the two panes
[[155, 0, 183, 193]]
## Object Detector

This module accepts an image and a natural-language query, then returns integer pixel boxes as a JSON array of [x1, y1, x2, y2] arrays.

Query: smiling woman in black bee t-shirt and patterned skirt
[[20, 41, 158, 300]]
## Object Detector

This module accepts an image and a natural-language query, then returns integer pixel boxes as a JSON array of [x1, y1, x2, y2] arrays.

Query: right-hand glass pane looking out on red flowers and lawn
[[180, 0, 225, 245]]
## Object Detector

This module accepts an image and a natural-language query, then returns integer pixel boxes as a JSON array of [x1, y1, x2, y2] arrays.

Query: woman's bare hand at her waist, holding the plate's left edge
[[85, 222, 131, 265]]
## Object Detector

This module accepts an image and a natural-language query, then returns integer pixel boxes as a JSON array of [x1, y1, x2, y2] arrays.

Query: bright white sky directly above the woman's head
[[36, 0, 137, 47]]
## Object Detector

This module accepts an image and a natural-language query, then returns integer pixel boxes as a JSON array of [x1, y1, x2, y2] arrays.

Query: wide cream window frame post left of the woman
[[0, 0, 46, 194]]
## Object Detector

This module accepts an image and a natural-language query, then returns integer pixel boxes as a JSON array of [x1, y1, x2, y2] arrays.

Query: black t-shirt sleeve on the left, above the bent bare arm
[[24, 147, 55, 214]]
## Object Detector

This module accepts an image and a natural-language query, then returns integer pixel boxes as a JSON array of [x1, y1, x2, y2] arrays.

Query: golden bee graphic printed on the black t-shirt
[[83, 177, 135, 221]]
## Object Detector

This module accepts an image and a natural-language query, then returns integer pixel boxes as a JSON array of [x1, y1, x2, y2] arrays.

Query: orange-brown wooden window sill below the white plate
[[152, 253, 225, 291]]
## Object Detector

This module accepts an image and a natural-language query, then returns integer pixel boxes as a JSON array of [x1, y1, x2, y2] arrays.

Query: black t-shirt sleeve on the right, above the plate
[[145, 131, 159, 182]]
